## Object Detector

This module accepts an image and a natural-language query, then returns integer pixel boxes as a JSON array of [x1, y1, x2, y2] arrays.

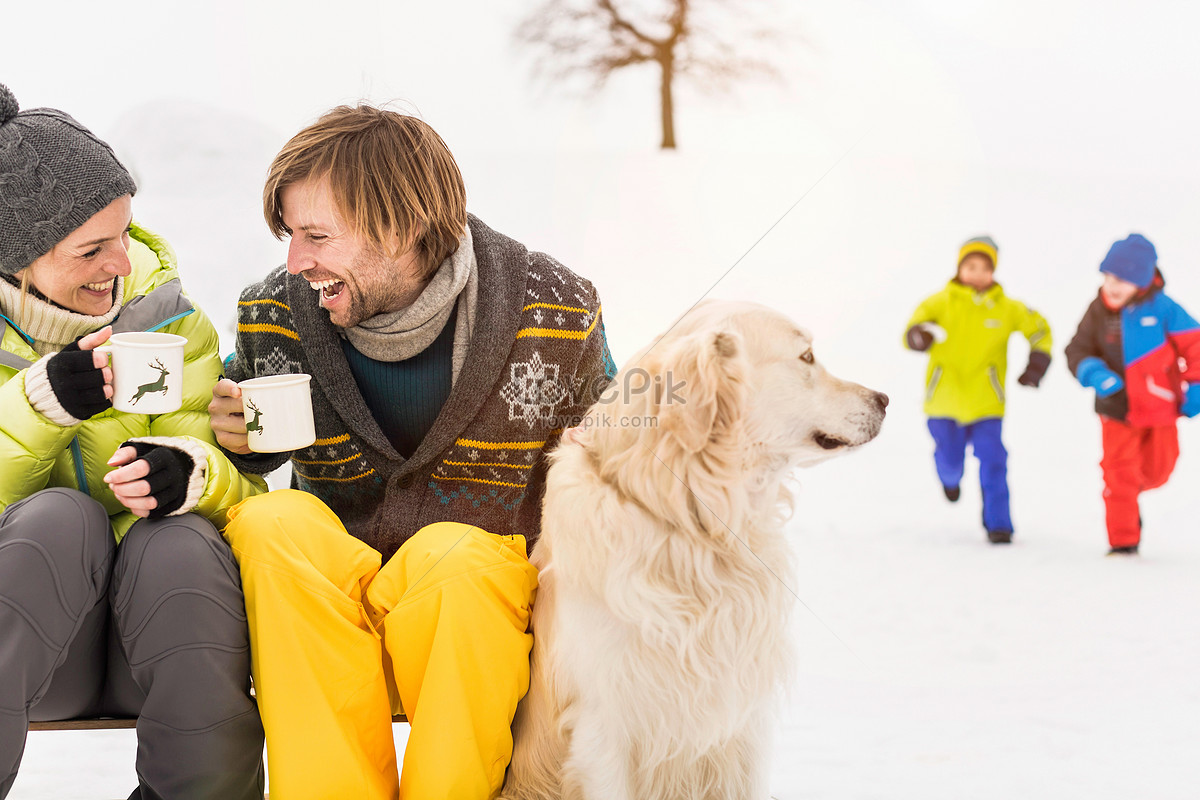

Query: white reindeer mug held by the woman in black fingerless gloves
[[96, 331, 187, 414]]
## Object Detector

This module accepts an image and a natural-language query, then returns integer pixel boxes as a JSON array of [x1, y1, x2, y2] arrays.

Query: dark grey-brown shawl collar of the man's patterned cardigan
[[284, 215, 529, 473]]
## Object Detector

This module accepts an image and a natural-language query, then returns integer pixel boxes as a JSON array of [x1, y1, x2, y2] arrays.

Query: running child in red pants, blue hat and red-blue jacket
[[1067, 234, 1200, 554]]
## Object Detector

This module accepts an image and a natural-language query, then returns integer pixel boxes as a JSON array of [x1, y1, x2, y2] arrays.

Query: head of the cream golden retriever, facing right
[[578, 301, 888, 479]]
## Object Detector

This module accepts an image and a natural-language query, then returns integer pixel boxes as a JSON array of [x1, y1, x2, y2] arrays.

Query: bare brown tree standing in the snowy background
[[517, 0, 778, 149]]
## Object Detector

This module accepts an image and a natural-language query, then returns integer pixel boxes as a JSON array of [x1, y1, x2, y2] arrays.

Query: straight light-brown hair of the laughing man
[[263, 104, 467, 278]]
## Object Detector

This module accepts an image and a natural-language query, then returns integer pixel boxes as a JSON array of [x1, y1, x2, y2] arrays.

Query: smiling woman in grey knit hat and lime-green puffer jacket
[[0, 84, 265, 800]]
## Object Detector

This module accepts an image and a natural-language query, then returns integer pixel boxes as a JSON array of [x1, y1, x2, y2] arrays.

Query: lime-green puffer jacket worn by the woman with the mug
[[0, 224, 266, 541]]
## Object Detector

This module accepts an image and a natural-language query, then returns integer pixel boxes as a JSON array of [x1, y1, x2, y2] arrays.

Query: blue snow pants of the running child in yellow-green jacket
[[929, 416, 1013, 531]]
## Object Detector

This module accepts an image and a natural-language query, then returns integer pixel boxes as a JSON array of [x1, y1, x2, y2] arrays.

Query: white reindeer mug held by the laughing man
[[238, 373, 317, 452]]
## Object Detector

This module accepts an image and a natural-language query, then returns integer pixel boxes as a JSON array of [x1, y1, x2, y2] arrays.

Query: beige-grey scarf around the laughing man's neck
[[346, 228, 479, 379]]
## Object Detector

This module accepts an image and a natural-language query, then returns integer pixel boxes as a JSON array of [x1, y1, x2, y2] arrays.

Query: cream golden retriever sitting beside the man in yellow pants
[[502, 301, 888, 800]]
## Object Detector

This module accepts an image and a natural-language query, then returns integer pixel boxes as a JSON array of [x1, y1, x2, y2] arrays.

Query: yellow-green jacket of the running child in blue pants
[[905, 278, 1052, 425]]
